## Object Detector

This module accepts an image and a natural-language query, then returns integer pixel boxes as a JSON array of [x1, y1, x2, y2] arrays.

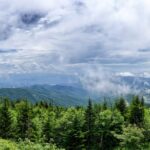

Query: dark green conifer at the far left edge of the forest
[[0, 99, 12, 139]]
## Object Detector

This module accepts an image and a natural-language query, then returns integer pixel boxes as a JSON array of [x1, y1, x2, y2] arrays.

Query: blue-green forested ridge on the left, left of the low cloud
[[0, 85, 89, 106]]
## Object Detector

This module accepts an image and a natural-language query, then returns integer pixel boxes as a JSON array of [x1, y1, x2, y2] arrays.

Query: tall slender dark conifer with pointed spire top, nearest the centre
[[85, 99, 95, 150]]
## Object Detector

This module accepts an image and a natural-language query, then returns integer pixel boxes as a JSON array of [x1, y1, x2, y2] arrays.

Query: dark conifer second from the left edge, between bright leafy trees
[[17, 101, 32, 139]]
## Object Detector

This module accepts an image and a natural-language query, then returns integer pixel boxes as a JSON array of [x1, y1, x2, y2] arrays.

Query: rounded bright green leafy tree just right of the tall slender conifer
[[95, 110, 124, 150]]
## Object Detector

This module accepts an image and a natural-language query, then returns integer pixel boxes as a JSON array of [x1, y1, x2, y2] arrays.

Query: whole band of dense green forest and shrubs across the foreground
[[0, 96, 150, 150]]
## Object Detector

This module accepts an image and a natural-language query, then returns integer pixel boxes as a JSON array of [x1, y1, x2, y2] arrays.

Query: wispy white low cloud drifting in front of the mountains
[[80, 67, 138, 96]]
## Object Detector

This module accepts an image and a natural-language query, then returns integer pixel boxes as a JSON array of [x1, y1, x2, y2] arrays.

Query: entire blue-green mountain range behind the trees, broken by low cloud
[[0, 75, 150, 106]]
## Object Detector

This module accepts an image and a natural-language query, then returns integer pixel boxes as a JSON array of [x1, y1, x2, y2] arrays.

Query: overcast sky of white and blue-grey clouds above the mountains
[[0, 0, 150, 90]]
